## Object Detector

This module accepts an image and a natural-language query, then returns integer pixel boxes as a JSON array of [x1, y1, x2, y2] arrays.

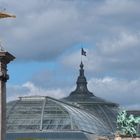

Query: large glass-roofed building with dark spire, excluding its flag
[[6, 62, 140, 140]]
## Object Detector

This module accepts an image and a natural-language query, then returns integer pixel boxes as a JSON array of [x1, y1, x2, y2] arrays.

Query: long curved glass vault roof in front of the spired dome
[[7, 96, 111, 135]]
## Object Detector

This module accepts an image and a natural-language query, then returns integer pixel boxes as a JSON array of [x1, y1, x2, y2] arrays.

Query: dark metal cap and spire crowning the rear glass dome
[[63, 62, 118, 106]]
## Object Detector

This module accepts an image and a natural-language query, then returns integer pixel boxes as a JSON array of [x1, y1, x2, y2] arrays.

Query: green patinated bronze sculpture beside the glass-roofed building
[[117, 110, 140, 137]]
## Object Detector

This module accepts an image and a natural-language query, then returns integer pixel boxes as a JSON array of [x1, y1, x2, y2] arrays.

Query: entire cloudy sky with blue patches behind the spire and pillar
[[0, 0, 140, 109]]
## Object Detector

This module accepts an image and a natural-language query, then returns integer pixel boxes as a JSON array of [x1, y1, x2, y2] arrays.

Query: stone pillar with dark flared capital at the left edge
[[0, 51, 15, 140]]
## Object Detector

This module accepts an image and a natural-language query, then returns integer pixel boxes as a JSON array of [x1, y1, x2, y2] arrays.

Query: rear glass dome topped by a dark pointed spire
[[61, 62, 118, 132]]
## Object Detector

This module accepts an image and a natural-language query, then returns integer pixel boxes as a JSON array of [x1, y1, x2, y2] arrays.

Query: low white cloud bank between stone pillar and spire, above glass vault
[[7, 81, 68, 101]]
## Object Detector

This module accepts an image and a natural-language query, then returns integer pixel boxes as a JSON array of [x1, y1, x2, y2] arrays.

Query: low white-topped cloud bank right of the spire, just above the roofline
[[88, 77, 140, 109]]
